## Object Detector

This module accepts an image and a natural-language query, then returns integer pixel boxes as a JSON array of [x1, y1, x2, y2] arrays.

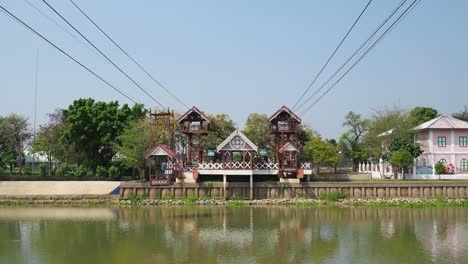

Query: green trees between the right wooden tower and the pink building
[[305, 106, 468, 177]]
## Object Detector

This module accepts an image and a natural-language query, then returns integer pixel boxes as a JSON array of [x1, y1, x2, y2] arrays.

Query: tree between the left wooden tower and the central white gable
[[203, 113, 236, 149]]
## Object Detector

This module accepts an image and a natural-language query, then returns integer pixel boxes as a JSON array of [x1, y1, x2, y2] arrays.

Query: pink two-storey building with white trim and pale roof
[[414, 115, 468, 174]]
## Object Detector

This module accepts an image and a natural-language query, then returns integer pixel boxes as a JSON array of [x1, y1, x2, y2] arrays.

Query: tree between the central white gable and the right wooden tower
[[243, 113, 273, 153]]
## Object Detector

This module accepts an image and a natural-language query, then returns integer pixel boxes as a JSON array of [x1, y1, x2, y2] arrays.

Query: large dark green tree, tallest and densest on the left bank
[[63, 98, 145, 171]]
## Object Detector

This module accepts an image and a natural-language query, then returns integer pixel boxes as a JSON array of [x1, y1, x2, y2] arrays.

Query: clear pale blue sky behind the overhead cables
[[0, 0, 468, 138]]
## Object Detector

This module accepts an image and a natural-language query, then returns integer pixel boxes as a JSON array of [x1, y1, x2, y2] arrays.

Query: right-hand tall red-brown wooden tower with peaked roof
[[269, 106, 301, 178]]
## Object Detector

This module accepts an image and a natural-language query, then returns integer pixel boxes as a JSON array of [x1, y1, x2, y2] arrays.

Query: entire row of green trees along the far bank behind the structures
[[0, 98, 468, 178]]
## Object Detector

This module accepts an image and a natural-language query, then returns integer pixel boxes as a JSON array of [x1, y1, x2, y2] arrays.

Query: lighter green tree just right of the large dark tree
[[114, 119, 150, 180]]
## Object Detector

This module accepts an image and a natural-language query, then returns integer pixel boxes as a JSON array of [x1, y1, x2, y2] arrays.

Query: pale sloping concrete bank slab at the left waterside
[[0, 181, 120, 196]]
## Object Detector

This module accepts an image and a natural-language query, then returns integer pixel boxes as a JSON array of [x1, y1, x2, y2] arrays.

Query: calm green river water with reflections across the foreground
[[0, 207, 468, 264]]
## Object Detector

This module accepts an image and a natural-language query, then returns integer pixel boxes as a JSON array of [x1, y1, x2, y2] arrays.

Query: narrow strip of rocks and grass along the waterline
[[0, 195, 468, 208]]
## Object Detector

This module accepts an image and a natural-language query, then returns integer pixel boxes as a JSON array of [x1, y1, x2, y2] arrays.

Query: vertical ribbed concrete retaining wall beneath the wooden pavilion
[[120, 181, 468, 199]]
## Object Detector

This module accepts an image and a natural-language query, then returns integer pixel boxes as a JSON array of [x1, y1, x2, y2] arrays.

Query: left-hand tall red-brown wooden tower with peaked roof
[[177, 106, 211, 165]]
